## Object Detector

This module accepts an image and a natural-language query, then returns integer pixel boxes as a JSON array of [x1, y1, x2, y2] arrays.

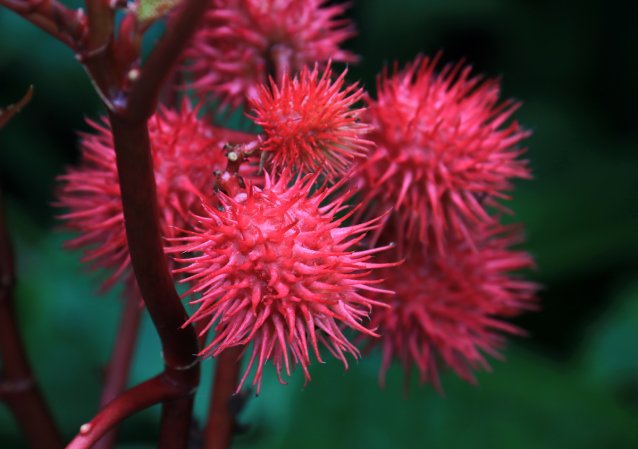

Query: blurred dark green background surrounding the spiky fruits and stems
[[0, 0, 638, 449]]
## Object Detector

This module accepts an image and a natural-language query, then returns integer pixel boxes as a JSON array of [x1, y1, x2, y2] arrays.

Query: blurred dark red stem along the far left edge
[[0, 192, 63, 449]]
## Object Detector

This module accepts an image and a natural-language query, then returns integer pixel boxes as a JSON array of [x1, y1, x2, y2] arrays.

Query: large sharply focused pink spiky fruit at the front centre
[[169, 172, 393, 390]]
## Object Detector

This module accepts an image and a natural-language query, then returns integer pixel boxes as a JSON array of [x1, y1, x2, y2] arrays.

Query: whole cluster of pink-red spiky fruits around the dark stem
[[59, 0, 535, 388]]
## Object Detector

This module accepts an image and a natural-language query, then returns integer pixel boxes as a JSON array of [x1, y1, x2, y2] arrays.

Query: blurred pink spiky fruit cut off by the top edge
[[185, 0, 356, 107]]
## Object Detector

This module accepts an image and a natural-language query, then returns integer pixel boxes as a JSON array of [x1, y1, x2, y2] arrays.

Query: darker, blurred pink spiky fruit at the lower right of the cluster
[[370, 227, 538, 390]]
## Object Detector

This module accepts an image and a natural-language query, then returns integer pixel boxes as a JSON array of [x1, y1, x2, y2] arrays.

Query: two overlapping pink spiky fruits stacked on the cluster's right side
[[354, 57, 536, 386]]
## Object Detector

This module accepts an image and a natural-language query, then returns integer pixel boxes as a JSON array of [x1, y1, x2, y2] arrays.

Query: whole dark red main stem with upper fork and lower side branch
[[0, 0, 210, 449]]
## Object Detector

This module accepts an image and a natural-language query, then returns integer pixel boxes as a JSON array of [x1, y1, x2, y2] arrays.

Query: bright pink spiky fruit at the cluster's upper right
[[357, 54, 530, 253]]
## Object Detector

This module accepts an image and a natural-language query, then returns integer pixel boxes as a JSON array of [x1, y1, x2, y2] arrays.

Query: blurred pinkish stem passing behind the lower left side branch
[[94, 293, 142, 449]]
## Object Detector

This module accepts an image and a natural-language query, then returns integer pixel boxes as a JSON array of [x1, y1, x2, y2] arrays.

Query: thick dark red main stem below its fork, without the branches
[[110, 113, 199, 449]]
